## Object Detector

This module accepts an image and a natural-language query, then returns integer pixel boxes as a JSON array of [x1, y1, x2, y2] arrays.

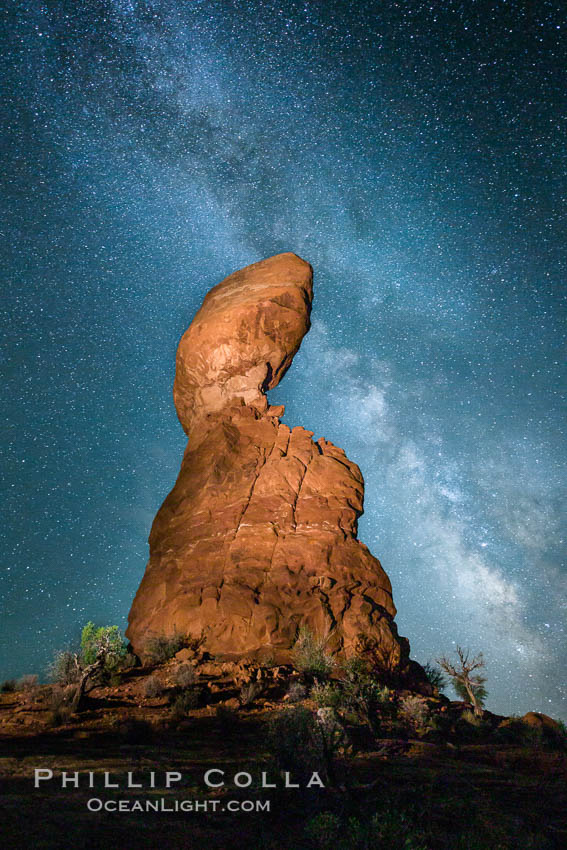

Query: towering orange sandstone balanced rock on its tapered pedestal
[[126, 254, 408, 667]]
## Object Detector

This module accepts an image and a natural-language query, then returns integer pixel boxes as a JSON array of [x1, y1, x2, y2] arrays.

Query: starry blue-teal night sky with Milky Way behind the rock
[[0, 0, 567, 720]]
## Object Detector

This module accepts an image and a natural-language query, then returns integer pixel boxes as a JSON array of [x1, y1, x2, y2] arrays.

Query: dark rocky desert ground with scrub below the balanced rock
[[0, 650, 567, 850]]
